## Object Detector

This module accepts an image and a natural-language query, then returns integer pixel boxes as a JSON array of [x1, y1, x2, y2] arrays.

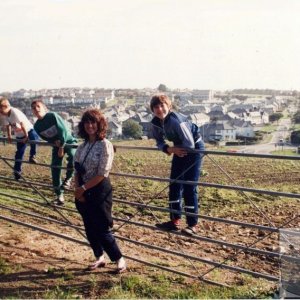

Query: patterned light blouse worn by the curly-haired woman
[[74, 139, 114, 183]]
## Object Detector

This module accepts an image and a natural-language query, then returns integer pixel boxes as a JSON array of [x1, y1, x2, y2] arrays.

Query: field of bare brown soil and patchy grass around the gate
[[0, 141, 300, 299]]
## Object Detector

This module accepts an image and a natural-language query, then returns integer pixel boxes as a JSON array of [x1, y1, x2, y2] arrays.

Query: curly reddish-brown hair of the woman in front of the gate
[[78, 109, 108, 141]]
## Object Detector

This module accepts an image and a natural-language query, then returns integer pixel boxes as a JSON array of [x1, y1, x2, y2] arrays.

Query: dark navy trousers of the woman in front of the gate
[[75, 178, 122, 261]]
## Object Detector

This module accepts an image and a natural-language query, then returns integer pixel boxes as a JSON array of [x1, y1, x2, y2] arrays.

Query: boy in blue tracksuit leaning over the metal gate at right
[[150, 95, 204, 235]]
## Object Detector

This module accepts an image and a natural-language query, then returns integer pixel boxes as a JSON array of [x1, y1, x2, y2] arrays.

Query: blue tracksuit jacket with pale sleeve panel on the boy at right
[[151, 112, 201, 153]]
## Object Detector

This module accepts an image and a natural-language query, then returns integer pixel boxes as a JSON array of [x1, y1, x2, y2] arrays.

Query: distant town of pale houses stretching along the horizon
[[0, 84, 300, 143]]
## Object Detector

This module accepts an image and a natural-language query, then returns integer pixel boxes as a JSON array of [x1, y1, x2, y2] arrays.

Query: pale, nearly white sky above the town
[[0, 0, 300, 92]]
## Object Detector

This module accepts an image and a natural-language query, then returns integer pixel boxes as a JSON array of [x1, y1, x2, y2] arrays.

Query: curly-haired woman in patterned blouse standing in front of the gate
[[75, 109, 126, 273]]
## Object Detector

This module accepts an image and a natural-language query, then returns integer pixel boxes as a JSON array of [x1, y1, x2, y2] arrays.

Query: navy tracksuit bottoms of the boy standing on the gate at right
[[169, 141, 204, 226]]
